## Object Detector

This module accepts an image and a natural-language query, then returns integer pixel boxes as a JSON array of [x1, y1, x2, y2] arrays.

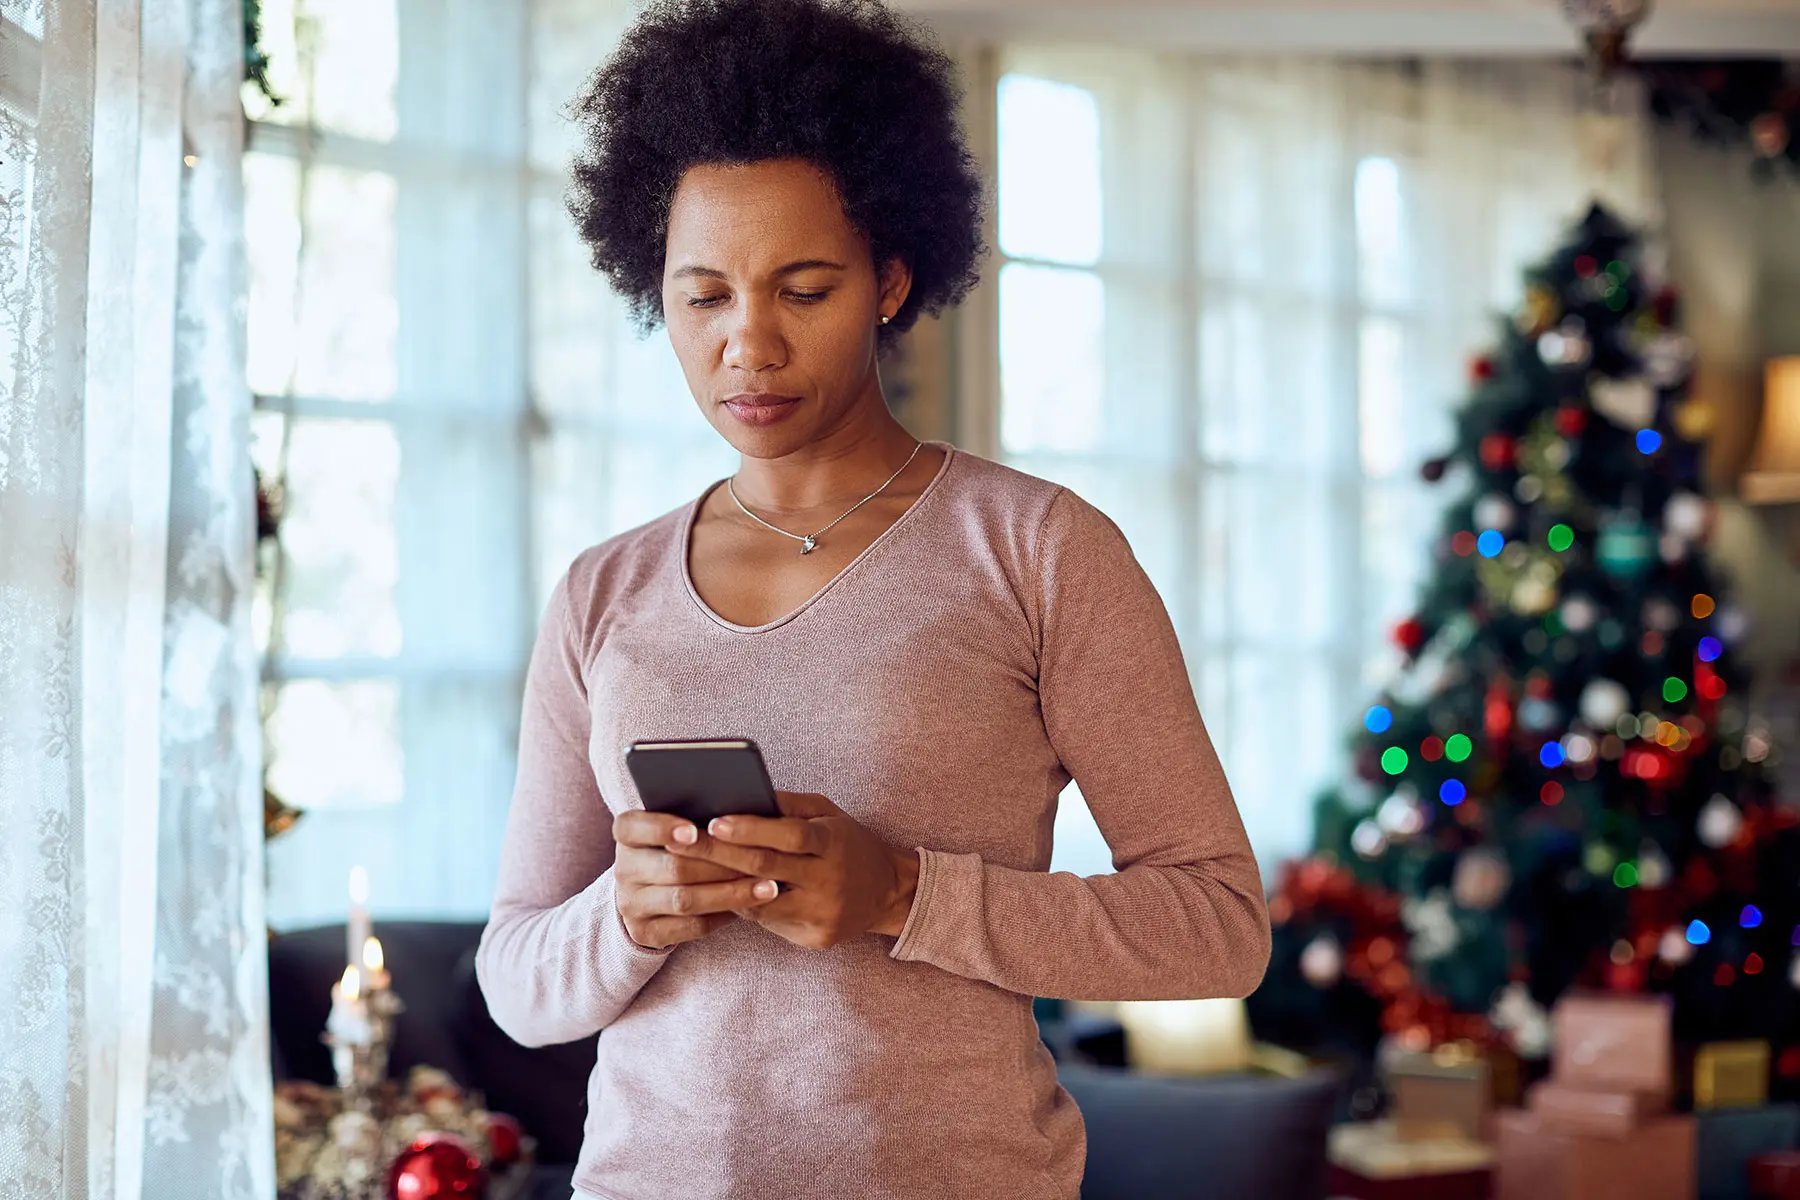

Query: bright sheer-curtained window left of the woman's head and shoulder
[[245, 0, 731, 928]]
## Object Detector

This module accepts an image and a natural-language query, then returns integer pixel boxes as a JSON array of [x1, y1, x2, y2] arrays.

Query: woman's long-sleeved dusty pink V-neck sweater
[[475, 443, 1269, 1200]]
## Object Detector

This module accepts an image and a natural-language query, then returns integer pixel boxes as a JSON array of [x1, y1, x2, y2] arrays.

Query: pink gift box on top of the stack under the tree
[[1552, 995, 1672, 1096]]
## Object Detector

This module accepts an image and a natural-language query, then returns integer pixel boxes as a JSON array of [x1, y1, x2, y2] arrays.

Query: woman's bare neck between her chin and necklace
[[733, 413, 918, 515]]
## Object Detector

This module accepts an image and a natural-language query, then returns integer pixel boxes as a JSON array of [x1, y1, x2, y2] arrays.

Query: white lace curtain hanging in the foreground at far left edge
[[0, 0, 274, 1200]]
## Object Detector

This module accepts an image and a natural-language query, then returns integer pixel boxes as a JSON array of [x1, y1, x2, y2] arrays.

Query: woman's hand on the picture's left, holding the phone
[[612, 810, 779, 950]]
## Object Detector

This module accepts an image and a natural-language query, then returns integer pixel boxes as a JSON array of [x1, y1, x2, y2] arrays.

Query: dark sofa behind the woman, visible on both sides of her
[[268, 921, 1343, 1200]]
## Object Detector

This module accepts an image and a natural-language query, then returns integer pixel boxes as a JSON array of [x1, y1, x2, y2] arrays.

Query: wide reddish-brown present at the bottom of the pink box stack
[[1494, 1108, 1696, 1200]]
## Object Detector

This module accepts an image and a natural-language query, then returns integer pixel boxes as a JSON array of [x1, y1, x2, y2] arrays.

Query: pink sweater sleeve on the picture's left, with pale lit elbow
[[475, 576, 668, 1045]]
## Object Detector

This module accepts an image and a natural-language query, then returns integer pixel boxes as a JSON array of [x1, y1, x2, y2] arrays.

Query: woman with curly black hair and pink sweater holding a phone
[[477, 0, 1269, 1200]]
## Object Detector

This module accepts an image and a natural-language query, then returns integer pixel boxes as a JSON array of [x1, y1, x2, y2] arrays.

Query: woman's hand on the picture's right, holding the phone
[[670, 792, 918, 950]]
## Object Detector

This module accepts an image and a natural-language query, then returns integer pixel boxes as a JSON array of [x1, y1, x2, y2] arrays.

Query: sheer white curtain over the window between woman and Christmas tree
[[986, 45, 1658, 873]]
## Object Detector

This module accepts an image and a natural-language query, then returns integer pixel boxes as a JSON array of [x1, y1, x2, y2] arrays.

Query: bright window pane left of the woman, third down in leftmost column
[[281, 421, 401, 658]]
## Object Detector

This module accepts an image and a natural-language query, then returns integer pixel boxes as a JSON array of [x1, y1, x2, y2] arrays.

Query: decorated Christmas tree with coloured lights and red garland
[[1253, 209, 1800, 1090]]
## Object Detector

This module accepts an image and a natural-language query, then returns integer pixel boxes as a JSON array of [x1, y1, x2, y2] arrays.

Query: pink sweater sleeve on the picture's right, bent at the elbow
[[891, 489, 1269, 1000]]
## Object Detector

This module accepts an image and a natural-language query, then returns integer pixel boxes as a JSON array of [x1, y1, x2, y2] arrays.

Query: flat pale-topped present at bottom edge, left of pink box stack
[[1327, 1121, 1494, 1200]]
